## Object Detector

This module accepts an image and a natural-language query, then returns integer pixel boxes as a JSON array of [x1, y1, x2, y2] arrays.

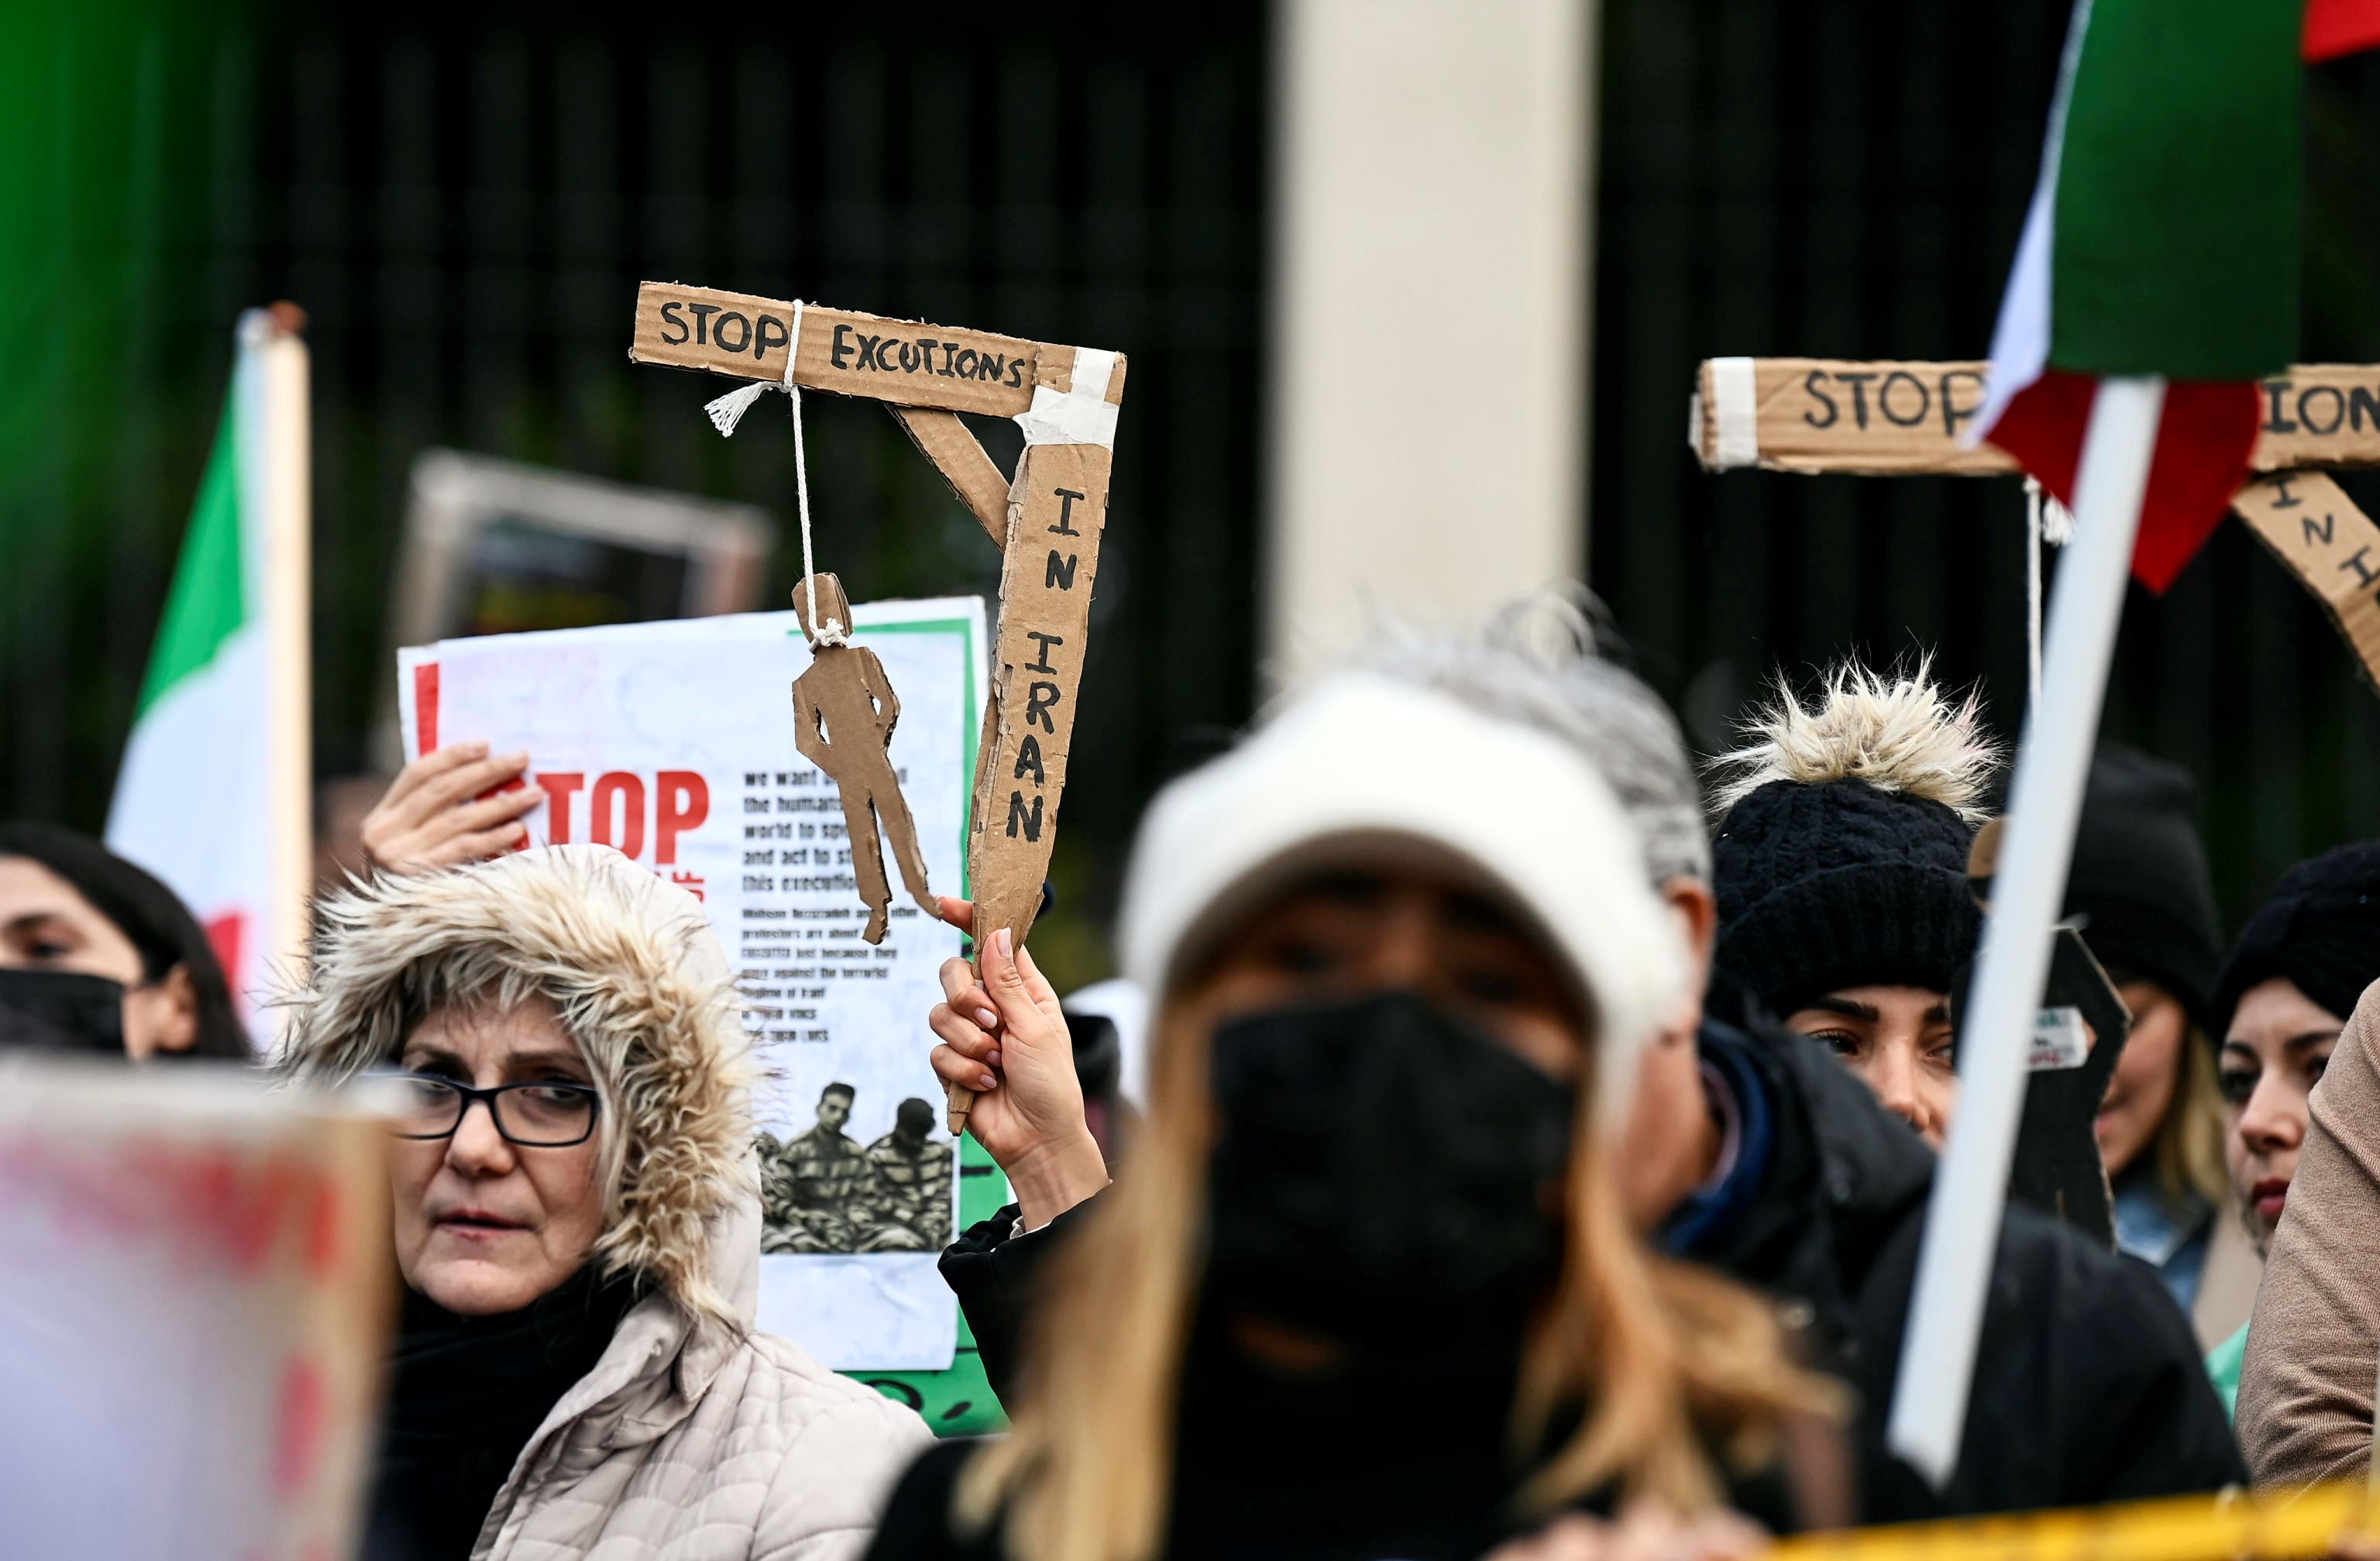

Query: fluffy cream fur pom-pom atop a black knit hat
[[1711, 657, 1999, 823]]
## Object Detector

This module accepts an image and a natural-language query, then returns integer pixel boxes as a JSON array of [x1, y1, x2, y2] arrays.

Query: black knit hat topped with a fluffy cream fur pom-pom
[[1711, 662, 1999, 1014]]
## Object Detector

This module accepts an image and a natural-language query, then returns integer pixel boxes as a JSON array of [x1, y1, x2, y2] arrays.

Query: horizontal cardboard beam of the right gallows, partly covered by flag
[[1690, 357, 2380, 476]]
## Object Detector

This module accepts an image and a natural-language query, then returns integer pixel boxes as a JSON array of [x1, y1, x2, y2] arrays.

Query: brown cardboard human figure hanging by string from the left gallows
[[793, 573, 935, 942]]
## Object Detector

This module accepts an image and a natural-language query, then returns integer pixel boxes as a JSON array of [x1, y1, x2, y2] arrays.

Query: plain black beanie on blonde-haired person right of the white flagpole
[[2065, 742, 2223, 1035]]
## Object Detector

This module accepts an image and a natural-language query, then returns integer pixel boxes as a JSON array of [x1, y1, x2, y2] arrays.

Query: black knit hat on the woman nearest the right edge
[[2209, 840, 2380, 1044]]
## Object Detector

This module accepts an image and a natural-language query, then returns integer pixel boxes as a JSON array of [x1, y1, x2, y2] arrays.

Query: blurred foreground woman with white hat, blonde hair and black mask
[[871, 676, 1830, 1561]]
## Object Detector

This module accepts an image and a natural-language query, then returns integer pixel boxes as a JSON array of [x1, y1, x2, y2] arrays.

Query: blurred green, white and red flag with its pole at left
[[107, 304, 311, 1033]]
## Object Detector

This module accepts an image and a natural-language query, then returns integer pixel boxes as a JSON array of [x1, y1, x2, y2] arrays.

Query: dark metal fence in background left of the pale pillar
[[0, 5, 1266, 989]]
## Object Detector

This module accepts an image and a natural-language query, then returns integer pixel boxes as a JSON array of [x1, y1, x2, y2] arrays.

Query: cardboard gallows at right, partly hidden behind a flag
[[1687, 357, 2380, 688]]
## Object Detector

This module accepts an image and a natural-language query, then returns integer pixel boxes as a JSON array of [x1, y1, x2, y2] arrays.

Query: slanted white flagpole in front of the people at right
[[1885, 376, 2166, 1487]]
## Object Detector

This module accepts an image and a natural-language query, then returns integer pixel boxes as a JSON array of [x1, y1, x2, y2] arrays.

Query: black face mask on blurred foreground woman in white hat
[[1207, 992, 1576, 1347]]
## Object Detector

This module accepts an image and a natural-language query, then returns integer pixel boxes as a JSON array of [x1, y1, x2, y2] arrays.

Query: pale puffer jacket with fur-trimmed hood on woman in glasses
[[280, 848, 933, 1561]]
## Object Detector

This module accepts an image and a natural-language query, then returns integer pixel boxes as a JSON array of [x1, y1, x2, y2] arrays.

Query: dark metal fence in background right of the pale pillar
[[1592, 0, 2380, 923]]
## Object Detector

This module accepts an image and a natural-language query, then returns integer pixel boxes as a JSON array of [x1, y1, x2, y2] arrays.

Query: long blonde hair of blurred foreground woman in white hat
[[954, 999, 1845, 1561]]
